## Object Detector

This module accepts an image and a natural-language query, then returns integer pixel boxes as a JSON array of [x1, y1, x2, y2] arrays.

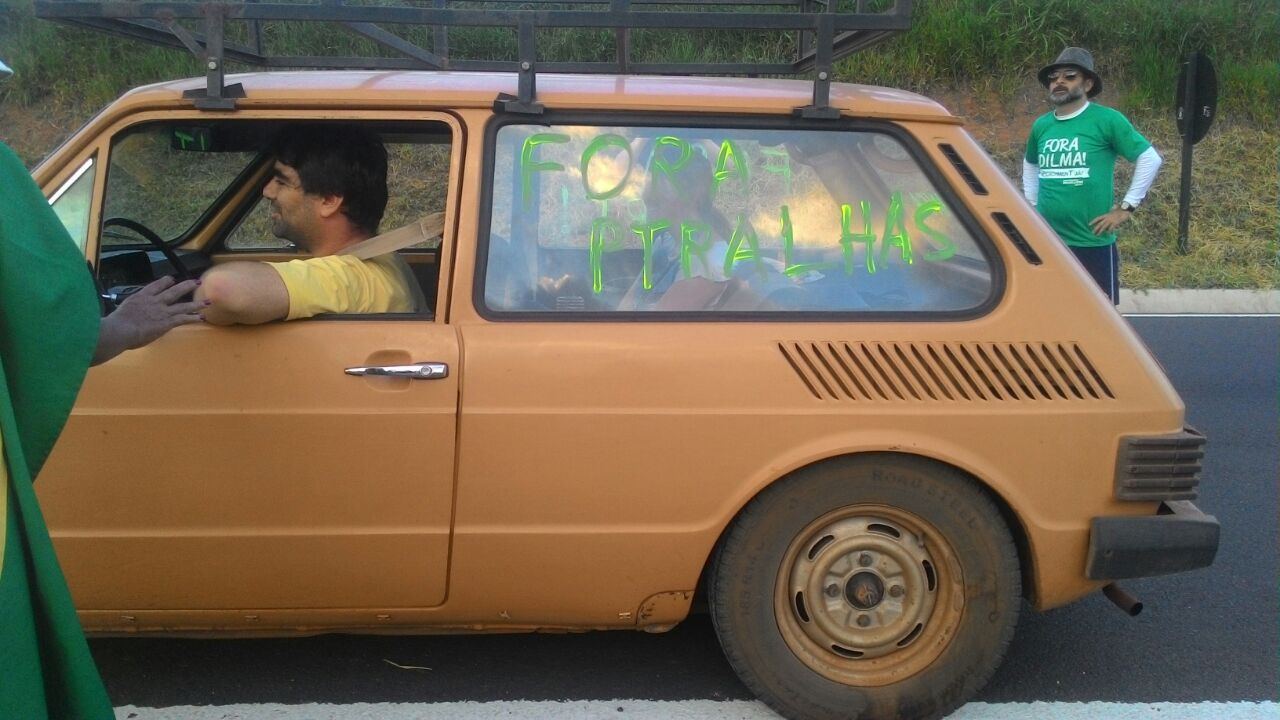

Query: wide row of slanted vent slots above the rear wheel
[[778, 341, 1115, 402]]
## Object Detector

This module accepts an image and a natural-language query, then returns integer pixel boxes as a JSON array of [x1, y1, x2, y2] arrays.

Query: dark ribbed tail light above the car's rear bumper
[[1116, 428, 1206, 502]]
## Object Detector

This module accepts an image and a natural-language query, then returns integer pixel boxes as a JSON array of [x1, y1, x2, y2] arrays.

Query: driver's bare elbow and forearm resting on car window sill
[[196, 261, 289, 325]]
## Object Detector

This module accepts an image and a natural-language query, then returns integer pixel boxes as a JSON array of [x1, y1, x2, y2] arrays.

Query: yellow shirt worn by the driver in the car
[[268, 254, 415, 320]]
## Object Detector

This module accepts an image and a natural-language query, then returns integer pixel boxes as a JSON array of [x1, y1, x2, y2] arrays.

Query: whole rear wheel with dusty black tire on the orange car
[[708, 454, 1021, 720]]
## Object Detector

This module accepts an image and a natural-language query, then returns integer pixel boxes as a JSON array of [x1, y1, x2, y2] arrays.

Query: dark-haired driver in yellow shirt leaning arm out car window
[[196, 124, 422, 325]]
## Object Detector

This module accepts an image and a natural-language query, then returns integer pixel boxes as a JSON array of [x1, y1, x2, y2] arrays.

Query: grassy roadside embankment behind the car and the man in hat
[[0, 0, 1280, 288]]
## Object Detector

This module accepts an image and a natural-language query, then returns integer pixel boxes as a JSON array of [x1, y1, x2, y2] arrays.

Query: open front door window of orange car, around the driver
[[99, 117, 456, 316]]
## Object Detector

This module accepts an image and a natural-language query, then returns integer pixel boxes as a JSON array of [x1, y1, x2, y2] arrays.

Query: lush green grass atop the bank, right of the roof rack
[[846, 0, 1280, 126]]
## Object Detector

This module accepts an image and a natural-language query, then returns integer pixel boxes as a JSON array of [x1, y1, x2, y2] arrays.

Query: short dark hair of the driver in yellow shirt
[[269, 123, 387, 234]]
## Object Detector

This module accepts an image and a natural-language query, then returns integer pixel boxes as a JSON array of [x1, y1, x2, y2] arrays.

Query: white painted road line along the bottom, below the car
[[115, 700, 1280, 720]]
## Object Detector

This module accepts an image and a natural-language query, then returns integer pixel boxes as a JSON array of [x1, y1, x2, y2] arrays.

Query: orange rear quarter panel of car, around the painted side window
[[435, 107, 1181, 624]]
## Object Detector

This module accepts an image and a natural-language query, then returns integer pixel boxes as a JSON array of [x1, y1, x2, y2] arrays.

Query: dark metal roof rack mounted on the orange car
[[35, 0, 911, 118]]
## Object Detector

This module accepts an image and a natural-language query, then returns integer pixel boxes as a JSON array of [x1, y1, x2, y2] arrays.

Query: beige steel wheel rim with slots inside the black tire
[[773, 505, 965, 687]]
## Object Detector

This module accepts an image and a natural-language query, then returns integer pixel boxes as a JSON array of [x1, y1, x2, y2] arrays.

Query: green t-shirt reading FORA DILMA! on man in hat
[[1027, 102, 1151, 247]]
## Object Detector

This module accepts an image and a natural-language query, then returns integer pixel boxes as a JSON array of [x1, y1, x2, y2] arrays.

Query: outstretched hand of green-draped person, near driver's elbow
[[93, 277, 207, 365]]
